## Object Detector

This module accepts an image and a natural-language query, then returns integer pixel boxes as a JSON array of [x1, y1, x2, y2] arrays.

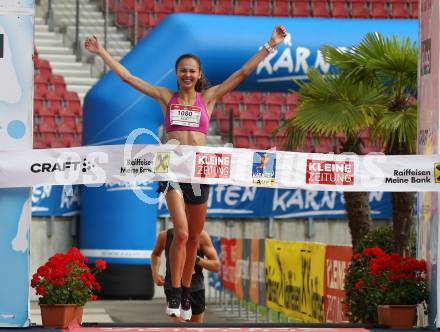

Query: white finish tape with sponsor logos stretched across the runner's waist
[[0, 143, 440, 192]]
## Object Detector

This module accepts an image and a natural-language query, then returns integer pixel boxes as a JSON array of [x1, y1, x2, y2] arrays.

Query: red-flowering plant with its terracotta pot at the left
[[31, 247, 106, 328]]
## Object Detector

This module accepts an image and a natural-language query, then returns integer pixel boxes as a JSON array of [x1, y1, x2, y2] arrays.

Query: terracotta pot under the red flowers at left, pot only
[[40, 304, 84, 329]]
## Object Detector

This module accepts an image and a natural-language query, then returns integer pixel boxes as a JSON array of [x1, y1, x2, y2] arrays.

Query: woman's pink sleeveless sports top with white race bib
[[165, 92, 209, 134]]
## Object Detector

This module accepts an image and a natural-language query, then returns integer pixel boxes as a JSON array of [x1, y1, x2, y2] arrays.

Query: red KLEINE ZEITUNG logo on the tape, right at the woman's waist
[[194, 152, 231, 179]]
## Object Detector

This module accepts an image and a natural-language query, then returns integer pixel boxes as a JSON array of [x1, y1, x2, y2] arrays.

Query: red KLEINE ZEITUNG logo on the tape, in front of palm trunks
[[306, 159, 354, 186]]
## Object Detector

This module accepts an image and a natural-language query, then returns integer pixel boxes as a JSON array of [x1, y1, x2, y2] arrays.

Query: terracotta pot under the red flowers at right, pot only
[[377, 304, 416, 329]]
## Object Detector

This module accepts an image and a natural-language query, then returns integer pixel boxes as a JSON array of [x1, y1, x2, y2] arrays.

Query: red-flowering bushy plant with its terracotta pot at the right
[[345, 248, 428, 328]]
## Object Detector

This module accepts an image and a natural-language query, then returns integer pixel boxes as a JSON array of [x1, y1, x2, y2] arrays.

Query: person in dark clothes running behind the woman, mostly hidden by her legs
[[151, 228, 220, 323]]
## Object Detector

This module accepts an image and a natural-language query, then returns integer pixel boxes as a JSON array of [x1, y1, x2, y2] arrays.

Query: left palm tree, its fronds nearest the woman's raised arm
[[287, 70, 384, 251]]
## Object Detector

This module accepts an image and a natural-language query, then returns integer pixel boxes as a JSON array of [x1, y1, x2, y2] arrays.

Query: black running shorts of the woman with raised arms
[[157, 181, 209, 204]]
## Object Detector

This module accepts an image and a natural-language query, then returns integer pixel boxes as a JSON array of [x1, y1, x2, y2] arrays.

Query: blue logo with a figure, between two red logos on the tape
[[252, 152, 277, 185]]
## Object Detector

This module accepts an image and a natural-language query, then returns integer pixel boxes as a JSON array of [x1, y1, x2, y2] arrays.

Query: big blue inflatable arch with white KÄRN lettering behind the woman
[[80, 14, 418, 298]]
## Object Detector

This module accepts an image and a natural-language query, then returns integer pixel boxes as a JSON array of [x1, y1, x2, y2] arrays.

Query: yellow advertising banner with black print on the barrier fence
[[264, 240, 325, 323]]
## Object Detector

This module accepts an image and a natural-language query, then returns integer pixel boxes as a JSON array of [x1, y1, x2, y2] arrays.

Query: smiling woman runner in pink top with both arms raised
[[85, 25, 287, 320]]
